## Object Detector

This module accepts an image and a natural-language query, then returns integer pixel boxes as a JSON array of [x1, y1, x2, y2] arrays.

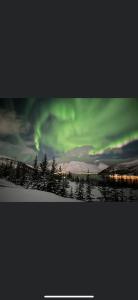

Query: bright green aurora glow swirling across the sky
[[34, 98, 138, 154]]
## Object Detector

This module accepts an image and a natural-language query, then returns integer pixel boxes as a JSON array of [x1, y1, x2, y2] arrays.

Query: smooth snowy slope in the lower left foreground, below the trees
[[0, 179, 80, 202]]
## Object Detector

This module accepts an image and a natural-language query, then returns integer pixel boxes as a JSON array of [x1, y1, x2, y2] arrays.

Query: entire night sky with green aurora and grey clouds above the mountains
[[0, 97, 138, 162]]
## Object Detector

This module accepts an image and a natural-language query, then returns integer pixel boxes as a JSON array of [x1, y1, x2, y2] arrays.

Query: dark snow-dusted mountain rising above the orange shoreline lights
[[100, 160, 138, 175]]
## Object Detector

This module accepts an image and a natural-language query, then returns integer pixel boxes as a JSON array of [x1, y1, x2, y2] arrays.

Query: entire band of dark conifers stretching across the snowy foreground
[[0, 154, 138, 202]]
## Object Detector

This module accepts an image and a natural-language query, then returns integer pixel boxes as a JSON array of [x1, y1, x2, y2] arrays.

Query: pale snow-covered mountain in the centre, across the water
[[58, 161, 108, 174]]
